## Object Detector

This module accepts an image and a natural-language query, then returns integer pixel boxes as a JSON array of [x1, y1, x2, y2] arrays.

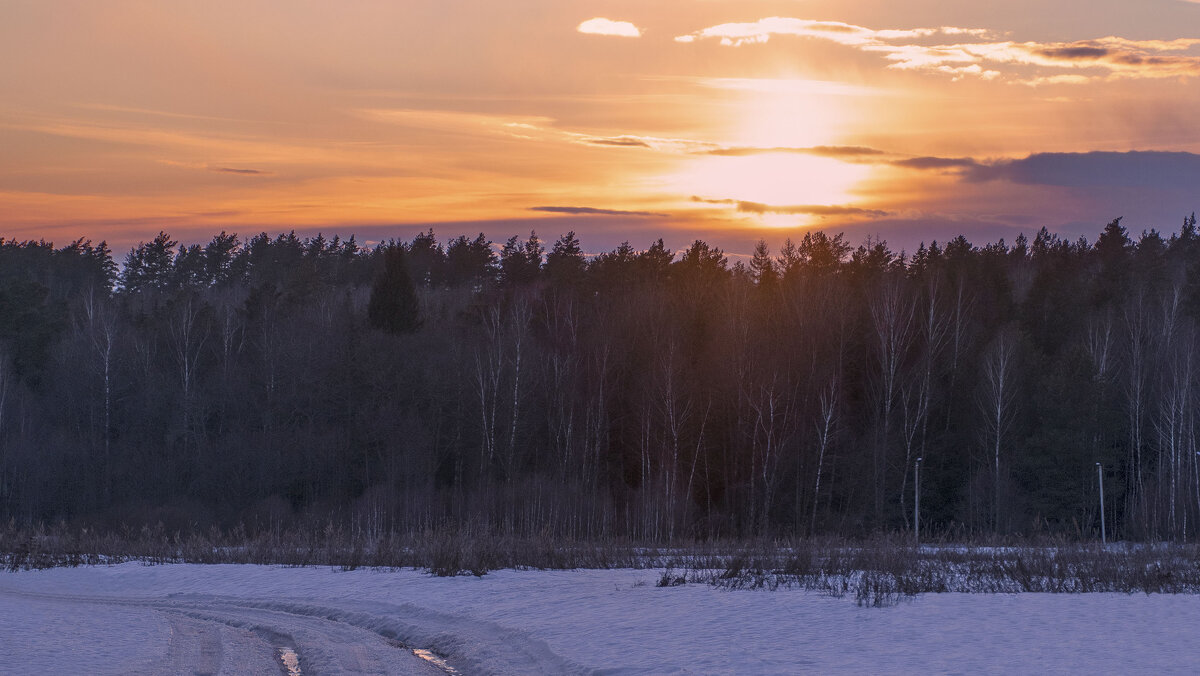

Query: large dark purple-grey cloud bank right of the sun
[[967, 151, 1200, 190]]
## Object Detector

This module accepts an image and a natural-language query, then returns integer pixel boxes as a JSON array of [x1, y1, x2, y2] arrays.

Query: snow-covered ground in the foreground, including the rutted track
[[0, 563, 1200, 675]]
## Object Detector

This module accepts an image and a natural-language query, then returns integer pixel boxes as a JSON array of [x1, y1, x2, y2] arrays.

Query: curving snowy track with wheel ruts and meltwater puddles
[[0, 592, 593, 676]]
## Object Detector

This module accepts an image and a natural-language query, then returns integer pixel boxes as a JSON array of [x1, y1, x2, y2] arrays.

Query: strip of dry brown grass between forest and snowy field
[[7, 522, 1200, 606]]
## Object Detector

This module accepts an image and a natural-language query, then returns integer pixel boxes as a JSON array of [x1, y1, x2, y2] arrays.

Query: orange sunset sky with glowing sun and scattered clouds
[[0, 0, 1200, 255]]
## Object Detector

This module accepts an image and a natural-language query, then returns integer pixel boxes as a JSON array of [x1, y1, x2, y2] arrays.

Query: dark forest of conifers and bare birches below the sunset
[[0, 215, 1200, 543]]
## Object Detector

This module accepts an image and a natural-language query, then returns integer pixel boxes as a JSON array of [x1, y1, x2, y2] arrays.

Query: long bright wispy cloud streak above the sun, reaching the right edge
[[676, 17, 1200, 85]]
